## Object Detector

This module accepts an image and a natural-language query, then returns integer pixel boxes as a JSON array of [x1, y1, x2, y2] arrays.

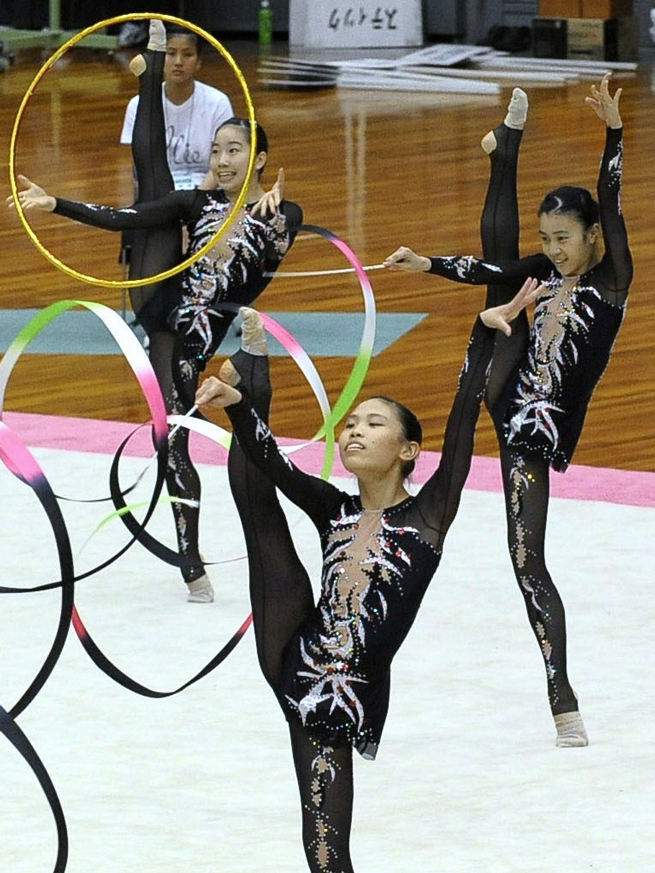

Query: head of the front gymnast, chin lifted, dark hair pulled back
[[339, 397, 419, 479]]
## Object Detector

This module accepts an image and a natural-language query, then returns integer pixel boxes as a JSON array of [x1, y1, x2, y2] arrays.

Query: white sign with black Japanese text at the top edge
[[289, 0, 423, 48]]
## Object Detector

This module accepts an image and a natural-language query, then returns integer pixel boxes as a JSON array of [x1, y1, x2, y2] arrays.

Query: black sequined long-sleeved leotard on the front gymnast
[[226, 319, 495, 758]]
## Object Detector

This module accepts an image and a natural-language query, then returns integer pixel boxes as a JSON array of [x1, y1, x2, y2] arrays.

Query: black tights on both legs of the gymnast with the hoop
[[129, 51, 205, 582]]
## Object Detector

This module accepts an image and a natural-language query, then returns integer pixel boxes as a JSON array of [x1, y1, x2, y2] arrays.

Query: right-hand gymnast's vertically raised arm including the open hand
[[585, 73, 633, 303]]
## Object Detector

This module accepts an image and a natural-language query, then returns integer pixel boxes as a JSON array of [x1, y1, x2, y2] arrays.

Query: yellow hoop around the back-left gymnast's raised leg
[[9, 12, 257, 288]]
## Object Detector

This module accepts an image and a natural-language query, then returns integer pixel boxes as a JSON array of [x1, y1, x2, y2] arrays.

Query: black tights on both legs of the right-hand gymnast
[[480, 125, 578, 715]]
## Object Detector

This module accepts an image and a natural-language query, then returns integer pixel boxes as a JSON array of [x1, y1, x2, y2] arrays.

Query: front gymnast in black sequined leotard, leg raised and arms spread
[[196, 280, 543, 873]]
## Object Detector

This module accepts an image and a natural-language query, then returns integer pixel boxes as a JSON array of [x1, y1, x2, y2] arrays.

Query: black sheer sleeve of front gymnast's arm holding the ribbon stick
[[225, 394, 344, 526]]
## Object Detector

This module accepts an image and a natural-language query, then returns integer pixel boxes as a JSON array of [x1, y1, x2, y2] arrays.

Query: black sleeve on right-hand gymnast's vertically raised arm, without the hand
[[597, 127, 633, 305]]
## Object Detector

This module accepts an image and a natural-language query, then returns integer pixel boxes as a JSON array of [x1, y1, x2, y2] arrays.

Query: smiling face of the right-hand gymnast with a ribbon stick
[[539, 212, 600, 276]]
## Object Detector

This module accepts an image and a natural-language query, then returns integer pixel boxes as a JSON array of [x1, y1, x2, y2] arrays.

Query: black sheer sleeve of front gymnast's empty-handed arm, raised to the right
[[416, 317, 496, 548]]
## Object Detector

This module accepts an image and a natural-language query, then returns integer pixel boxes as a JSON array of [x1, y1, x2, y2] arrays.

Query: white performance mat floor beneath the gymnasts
[[0, 449, 655, 873]]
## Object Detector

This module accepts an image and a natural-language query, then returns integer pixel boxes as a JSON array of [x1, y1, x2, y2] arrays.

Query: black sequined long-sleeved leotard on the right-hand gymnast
[[430, 128, 632, 471]]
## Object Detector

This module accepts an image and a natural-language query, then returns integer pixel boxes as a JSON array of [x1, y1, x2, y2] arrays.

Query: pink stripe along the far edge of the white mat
[[3, 412, 655, 507]]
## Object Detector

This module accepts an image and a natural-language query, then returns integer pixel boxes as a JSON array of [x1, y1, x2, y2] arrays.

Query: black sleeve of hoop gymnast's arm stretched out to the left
[[54, 190, 198, 230]]
